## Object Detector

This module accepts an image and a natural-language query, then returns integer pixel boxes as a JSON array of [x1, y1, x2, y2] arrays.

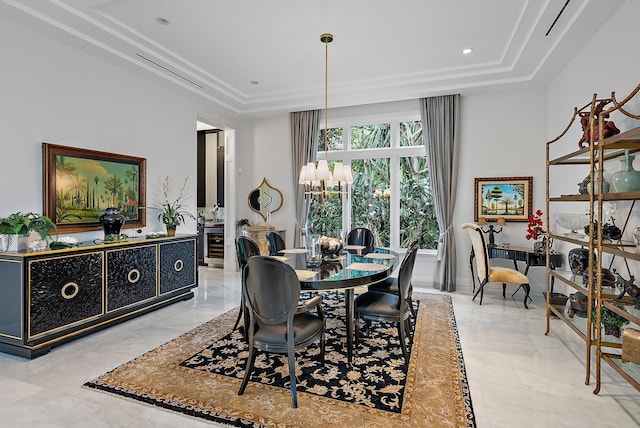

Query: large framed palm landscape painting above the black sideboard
[[42, 143, 147, 233]]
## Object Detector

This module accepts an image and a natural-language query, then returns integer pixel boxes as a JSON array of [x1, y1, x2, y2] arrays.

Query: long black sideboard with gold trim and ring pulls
[[0, 235, 198, 358]]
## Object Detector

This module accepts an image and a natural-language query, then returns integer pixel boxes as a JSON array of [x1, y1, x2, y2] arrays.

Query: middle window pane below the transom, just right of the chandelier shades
[[351, 158, 391, 247]]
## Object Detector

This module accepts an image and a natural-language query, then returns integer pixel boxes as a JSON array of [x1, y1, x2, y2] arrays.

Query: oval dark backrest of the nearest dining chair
[[242, 256, 300, 324]]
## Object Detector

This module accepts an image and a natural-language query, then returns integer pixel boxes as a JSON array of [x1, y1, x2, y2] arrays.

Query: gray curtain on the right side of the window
[[420, 94, 460, 291]]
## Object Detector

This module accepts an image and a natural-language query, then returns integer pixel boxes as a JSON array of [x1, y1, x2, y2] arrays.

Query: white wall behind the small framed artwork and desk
[[454, 89, 546, 291]]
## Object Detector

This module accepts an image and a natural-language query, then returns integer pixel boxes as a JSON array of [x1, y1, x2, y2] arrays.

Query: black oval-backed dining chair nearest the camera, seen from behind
[[238, 256, 325, 409]]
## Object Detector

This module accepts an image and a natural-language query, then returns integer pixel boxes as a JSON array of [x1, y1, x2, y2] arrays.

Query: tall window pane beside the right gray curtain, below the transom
[[400, 156, 439, 249]]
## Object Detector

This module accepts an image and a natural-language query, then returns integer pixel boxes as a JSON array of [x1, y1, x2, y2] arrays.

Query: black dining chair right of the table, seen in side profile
[[354, 241, 418, 364]]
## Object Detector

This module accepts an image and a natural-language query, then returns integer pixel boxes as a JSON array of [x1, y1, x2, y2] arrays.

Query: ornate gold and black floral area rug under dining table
[[84, 292, 475, 427]]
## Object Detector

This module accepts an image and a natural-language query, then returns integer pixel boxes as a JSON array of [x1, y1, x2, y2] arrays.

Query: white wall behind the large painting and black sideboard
[[0, 17, 235, 239]]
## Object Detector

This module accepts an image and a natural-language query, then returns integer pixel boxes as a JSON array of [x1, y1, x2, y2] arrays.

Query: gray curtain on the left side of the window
[[291, 110, 320, 247]]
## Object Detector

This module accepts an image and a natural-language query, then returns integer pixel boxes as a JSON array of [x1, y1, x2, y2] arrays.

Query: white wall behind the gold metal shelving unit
[[546, 0, 640, 292]]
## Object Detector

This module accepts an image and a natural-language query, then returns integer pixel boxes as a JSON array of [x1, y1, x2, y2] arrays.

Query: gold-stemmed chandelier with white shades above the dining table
[[298, 33, 353, 195]]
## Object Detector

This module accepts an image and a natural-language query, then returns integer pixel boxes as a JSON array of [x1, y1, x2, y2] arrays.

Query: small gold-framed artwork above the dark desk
[[474, 177, 533, 222]]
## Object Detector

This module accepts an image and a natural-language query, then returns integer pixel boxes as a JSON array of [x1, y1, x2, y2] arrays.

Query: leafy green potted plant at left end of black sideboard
[[0, 212, 58, 251]]
